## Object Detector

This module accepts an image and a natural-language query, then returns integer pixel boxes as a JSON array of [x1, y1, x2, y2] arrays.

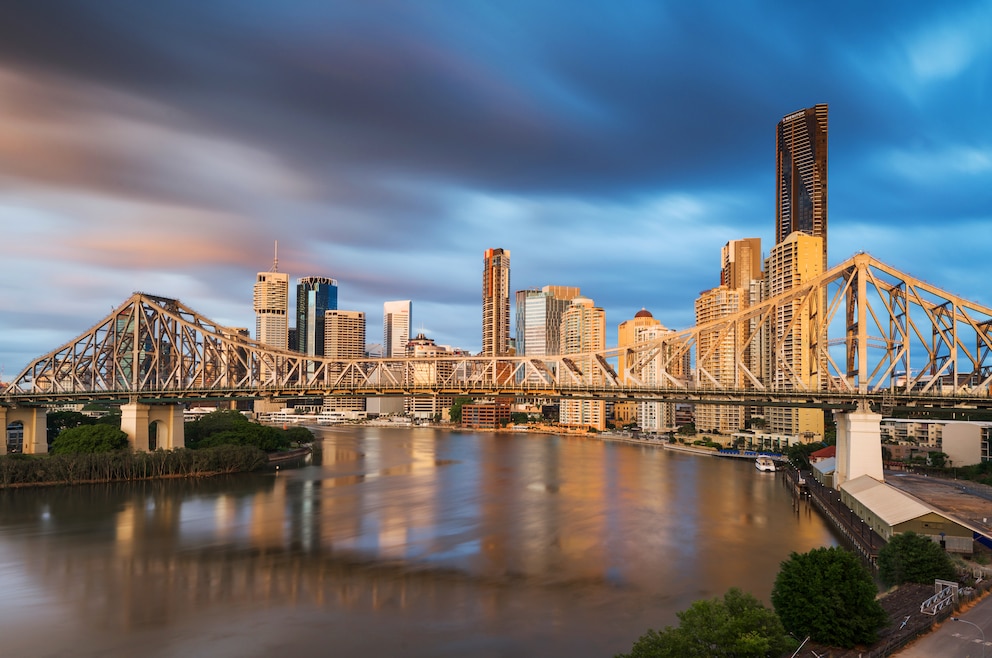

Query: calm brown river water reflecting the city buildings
[[0, 427, 838, 657]]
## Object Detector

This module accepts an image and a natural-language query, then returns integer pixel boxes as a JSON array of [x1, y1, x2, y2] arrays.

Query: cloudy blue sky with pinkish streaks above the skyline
[[0, 0, 992, 380]]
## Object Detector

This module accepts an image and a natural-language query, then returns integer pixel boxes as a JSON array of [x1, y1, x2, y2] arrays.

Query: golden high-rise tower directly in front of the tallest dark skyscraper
[[765, 232, 826, 443]]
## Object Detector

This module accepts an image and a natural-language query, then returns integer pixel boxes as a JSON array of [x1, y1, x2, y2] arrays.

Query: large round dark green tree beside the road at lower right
[[772, 546, 887, 648]]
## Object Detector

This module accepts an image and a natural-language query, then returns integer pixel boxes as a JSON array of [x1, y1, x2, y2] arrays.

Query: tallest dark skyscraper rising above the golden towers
[[775, 103, 827, 271]]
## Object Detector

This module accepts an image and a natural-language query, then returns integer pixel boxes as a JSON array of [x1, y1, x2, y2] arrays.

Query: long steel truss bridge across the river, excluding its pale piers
[[0, 254, 992, 411]]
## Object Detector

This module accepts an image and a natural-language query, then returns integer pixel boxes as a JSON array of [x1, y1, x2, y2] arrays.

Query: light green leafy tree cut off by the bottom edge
[[618, 588, 796, 658]]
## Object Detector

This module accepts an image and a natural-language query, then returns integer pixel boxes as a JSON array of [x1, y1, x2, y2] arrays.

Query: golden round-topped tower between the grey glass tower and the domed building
[[559, 297, 606, 430]]
